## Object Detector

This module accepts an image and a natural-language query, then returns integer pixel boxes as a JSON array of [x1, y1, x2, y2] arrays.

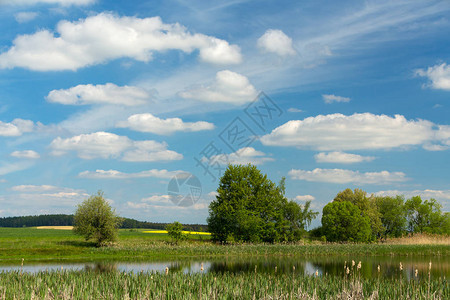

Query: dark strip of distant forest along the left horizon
[[0, 215, 208, 231]]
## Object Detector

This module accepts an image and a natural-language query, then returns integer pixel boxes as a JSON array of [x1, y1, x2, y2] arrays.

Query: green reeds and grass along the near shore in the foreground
[[0, 269, 450, 299]]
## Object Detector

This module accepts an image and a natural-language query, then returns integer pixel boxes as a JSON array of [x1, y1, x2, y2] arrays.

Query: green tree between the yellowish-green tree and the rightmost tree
[[375, 196, 406, 239]]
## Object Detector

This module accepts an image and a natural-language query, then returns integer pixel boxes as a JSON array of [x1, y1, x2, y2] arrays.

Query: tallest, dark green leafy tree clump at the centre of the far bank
[[207, 164, 316, 243]]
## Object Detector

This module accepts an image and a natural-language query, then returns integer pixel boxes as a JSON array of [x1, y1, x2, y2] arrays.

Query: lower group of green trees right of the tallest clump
[[311, 189, 450, 242]]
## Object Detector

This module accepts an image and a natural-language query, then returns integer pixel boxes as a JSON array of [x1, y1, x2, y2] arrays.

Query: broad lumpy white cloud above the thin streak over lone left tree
[[50, 132, 183, 162]]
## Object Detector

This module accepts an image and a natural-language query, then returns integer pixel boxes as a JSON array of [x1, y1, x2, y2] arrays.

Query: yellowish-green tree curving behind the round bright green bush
[[333, 189, 384, 240]]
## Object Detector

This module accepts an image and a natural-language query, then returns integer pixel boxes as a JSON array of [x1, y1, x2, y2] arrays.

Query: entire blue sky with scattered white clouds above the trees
[[0, 0, 450, 226]]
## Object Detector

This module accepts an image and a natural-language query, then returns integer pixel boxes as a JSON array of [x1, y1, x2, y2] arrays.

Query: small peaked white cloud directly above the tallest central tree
[[203, 147, 274, 165]]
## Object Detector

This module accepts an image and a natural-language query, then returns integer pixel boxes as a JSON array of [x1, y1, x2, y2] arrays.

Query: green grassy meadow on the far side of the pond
[[0, 228, 450, 263]]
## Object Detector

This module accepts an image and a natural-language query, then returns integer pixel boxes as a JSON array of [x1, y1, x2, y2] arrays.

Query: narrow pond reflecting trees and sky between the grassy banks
[[0, 256, 450, 278]]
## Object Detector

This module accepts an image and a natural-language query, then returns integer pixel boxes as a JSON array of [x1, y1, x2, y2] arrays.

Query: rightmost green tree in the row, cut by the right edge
[[405, 196, 450, 234]]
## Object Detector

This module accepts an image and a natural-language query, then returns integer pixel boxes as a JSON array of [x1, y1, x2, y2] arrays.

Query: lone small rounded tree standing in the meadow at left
[[73, 191, 121, 247]]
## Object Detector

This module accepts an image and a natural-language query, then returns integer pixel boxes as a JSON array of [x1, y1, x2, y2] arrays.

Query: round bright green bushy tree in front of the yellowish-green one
[[322, 201, 371, 242]]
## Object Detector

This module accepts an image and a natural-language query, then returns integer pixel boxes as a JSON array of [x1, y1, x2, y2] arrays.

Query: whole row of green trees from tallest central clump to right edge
[[207, 164, 450, 243]]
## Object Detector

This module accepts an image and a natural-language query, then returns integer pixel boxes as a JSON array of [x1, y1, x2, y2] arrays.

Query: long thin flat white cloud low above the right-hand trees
[[289, 168, 408, 184]]
